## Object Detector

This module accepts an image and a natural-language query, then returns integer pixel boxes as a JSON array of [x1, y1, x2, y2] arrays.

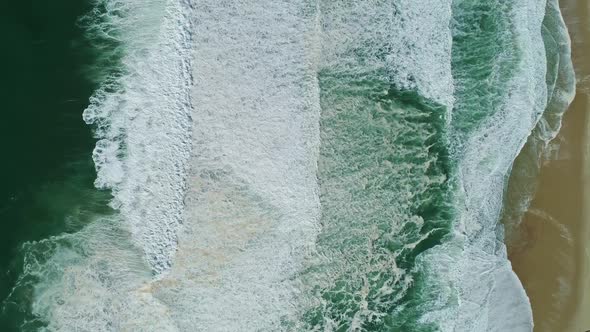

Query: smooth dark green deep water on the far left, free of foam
[[0, 0, 107, 331]]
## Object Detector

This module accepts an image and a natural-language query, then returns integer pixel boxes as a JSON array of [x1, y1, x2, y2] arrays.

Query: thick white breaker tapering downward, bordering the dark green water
[[84, 0, 192, 272]]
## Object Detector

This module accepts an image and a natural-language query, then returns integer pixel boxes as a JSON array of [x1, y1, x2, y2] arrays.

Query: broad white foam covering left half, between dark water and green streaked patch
[[23, 0, 319, 331]]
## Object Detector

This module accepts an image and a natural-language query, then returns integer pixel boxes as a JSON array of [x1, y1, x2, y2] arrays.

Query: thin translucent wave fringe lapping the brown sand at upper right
[[502, 0, 576, 246]]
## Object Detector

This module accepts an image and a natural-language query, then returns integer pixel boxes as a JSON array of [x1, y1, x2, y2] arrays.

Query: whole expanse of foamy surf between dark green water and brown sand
[[2, 0, 573, 332]]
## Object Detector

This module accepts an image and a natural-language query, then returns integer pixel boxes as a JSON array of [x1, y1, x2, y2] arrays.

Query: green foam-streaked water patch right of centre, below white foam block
[[305, 74, 456, 331]]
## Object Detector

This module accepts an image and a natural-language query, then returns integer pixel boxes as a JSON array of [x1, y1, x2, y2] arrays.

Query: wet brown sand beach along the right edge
[[507, 0, 590, 332]]
